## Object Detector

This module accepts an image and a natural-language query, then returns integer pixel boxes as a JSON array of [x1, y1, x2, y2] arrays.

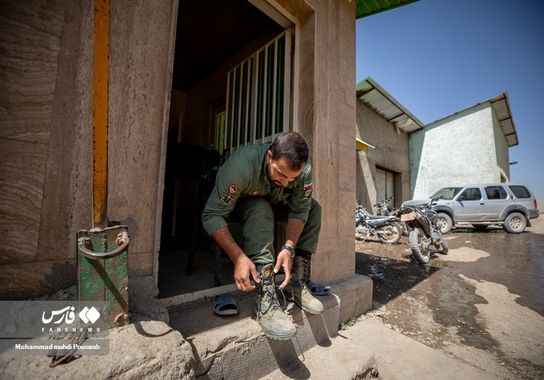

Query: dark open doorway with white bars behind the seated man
[[158, 0, 292, 298]]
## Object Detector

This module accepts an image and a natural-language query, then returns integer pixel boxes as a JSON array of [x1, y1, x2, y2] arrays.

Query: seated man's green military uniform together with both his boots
[[202, 144, 323, 340]]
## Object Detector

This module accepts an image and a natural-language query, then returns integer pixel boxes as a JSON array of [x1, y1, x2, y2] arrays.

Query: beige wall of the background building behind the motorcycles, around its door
[[356, 100, 410, 210]]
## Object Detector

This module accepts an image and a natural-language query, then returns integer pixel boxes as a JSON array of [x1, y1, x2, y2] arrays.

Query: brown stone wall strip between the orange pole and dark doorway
[[108, 0, 177, 276]]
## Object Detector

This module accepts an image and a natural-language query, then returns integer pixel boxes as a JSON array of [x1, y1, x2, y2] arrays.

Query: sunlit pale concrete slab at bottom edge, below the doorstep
[[263, 318, 495, 380]]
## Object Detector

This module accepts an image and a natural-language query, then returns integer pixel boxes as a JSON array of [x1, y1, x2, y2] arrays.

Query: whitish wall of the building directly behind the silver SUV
[[410, 103, 500, 199]]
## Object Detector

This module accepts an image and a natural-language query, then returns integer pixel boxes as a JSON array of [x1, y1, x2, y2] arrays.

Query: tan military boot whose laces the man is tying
[[257, 264, 296, 340]]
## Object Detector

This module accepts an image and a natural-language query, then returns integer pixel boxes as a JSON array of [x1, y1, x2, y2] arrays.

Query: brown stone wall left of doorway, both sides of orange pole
[[0, 0, 177, 299]]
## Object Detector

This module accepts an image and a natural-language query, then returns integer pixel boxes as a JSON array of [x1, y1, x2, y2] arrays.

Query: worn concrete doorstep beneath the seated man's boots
[[169, 275, 372, 379]]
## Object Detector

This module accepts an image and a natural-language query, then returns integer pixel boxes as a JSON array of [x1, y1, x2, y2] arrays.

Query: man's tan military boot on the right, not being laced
[[285, 256, 323, 314]]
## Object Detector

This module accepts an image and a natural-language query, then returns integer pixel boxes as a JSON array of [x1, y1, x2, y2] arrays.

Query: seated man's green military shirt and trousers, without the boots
[[202, 144, 321, 265]]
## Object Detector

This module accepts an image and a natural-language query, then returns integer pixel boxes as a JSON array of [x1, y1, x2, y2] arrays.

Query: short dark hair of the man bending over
[[270, 132, 308, 170]]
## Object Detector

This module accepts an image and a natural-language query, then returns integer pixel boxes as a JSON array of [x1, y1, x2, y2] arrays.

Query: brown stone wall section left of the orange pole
[[0, 0, 93, 299]]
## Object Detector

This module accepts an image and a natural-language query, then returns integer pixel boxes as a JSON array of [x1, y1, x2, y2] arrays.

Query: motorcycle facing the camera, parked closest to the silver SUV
[[398, 199, 448, 264]]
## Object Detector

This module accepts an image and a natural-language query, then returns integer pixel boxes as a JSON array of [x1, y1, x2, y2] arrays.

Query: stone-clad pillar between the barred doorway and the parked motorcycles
[[277, 0, 355, 282]]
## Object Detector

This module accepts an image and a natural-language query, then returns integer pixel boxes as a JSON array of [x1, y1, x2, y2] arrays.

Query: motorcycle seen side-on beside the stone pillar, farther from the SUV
[[355, 205, 401, 244]]
